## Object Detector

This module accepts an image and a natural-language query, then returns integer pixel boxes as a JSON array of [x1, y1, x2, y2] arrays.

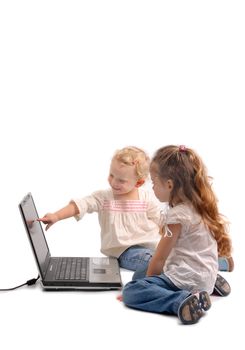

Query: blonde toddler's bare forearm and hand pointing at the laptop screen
[[37, 202, 79, 231]]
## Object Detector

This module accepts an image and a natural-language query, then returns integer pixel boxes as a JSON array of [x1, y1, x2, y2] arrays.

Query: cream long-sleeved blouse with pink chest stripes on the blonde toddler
[[72, 187, 161, 258]]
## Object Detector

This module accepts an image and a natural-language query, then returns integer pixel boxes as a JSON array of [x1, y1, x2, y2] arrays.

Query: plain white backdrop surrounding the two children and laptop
[[0, 0, 245, 350]]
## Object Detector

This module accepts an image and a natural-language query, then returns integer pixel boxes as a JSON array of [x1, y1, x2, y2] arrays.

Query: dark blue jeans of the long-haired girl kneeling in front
[[123, 274, 191, 315]]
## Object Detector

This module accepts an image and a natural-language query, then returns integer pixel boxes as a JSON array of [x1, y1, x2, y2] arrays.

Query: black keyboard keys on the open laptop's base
[[55, 258, 89, 281]]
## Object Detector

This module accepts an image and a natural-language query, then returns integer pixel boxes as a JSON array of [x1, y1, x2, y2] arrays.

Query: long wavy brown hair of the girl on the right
[[152, 146, 231, 256]]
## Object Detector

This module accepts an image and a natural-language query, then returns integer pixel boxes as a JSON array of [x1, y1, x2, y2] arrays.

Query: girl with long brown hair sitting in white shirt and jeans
[[123, 146, 231, 324]]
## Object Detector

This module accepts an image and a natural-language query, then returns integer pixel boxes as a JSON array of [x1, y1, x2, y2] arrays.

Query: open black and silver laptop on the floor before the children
[[19, 193, 122, 290]]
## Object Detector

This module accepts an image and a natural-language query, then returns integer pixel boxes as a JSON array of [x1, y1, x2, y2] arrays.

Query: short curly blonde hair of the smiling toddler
[[112, 146, 150, 180]]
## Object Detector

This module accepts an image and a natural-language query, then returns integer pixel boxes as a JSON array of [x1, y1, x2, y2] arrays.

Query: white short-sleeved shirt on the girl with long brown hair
[[161, 204, 218, 294]]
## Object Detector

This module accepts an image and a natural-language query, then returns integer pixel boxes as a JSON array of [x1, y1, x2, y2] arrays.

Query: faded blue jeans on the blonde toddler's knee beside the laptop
[[118, 245, 154, 271]]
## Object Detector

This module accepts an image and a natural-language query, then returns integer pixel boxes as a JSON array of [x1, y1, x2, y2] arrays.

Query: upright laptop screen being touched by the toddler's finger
[[19, 193, 50, 278]]
